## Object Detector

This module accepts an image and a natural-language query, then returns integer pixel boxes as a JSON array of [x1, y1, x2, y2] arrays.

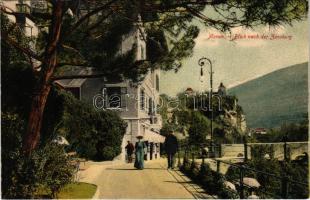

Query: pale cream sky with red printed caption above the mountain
[[160, 21, 309, 96]]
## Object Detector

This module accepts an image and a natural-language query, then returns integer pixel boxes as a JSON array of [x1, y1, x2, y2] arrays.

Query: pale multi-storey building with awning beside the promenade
[[56, 22, 164, 160]]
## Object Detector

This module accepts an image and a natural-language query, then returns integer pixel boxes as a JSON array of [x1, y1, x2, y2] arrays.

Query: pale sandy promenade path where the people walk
[[82, 159, 212, 199]]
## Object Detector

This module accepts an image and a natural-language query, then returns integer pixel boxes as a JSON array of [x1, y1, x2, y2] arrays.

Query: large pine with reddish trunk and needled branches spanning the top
[[1, 0, 308, 153]]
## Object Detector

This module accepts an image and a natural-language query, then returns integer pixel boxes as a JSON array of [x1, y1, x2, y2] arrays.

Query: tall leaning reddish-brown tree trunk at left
[[23, 0, 64, 154]]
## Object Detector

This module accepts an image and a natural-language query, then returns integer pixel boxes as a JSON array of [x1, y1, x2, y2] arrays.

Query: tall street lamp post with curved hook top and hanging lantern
[[198, 57, 214, 153]]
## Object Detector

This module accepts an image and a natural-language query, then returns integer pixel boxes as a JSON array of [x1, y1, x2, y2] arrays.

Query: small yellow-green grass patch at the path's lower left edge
[[37, 182, 97, 199]]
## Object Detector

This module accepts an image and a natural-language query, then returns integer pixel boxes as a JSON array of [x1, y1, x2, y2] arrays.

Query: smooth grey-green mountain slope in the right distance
[[228, 63, 308, 128]]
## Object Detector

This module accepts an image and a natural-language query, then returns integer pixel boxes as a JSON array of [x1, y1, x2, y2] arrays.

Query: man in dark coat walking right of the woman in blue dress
[[165, 131, 178, 169]]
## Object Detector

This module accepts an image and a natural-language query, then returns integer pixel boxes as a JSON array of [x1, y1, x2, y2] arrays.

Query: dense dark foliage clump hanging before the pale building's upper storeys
[[57, 0, 199, 81]]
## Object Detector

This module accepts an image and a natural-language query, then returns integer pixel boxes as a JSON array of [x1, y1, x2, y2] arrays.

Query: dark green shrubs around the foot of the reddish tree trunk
[[1, 113, 73, 198]]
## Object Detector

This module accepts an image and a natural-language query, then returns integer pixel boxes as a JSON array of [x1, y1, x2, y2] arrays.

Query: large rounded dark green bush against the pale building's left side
[[55, 92, 127, 160]]
